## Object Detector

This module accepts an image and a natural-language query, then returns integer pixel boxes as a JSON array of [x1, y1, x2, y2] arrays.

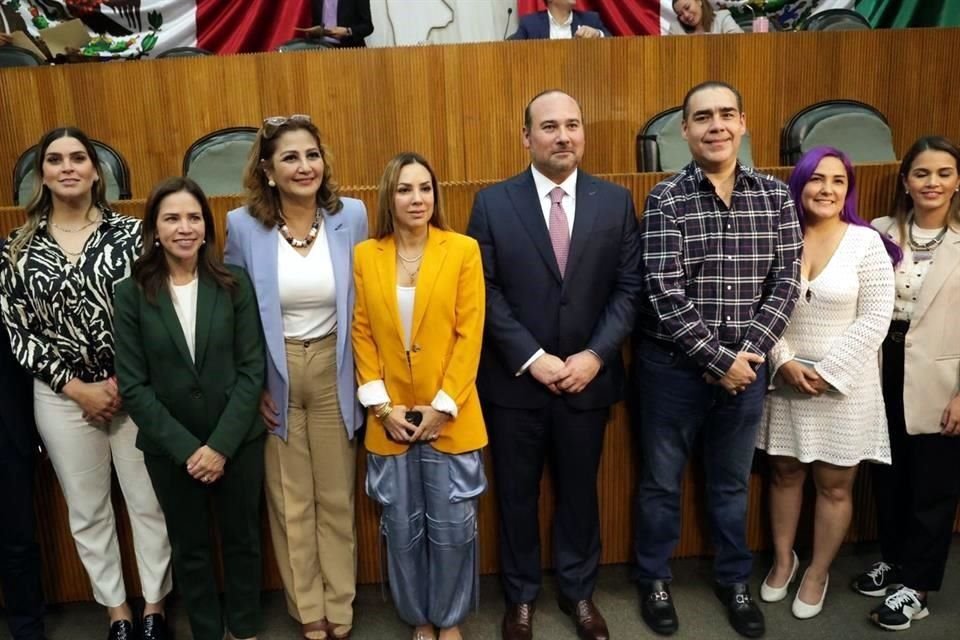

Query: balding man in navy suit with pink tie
[[467, 90, 642, 640]]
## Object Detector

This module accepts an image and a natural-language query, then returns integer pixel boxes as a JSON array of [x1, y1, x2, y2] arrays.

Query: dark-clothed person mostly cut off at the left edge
[[0, 240, 45, 640]]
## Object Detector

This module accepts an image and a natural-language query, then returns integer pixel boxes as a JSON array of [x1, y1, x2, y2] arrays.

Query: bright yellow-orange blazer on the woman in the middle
[[351, 227, 487, 456]]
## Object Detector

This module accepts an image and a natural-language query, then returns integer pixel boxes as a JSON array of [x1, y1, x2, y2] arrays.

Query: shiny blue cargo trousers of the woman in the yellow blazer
[[367, 444, 487, 629]]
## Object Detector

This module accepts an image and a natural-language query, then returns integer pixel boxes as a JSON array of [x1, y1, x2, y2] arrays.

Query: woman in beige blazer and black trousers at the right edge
[[853, 136, 960, 631]]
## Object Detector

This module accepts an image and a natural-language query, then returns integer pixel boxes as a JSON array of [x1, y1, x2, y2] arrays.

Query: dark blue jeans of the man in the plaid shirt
[[634, 340, 766, 585]]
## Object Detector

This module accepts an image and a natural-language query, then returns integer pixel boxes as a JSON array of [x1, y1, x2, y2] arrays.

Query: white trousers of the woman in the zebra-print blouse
[[33, 380, 172, 607]]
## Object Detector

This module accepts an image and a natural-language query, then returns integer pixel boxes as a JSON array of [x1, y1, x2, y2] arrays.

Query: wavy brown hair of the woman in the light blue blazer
[[243, 119, 343, 227]]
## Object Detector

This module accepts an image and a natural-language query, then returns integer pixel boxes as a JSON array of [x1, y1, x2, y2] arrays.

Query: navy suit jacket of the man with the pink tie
[[467, 170, 642, 410]]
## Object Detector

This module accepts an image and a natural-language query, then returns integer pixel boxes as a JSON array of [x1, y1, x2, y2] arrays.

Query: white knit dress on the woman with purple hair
[[757, 225, 894, 466]]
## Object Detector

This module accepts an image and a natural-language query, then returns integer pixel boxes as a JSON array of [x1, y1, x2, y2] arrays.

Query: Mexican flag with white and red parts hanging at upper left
[[0, 0, 311, 57]]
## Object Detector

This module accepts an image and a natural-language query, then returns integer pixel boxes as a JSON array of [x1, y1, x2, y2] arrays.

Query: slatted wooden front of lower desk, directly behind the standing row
[[0, 165, 960, 602]]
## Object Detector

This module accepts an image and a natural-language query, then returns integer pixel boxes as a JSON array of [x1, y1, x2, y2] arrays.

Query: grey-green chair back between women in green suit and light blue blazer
[[183, 127, 257, 196]]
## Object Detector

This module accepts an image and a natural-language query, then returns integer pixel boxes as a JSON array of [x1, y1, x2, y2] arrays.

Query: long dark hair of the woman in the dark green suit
[[132, 177, 237, 303]]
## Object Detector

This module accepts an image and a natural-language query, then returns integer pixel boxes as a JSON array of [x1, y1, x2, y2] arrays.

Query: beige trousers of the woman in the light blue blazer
[[265, 335, 357, 635]]
